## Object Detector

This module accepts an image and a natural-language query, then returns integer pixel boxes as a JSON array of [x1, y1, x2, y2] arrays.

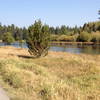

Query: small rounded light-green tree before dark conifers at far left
[[3, 32, 14, 44]]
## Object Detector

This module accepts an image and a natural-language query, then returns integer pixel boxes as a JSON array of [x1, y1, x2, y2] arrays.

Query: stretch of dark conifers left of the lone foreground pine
[[0, 23, 28, 41]]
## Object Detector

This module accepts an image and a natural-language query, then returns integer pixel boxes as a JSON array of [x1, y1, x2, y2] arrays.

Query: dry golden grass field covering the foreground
[[0, 47, 100, 100]]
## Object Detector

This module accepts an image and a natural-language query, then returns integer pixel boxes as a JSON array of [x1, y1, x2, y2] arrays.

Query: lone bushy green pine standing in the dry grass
[[26, 20, 50, 58]]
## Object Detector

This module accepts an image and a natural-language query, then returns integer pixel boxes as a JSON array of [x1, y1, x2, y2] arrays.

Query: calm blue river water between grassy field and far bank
[[0, 43, 100, 54]]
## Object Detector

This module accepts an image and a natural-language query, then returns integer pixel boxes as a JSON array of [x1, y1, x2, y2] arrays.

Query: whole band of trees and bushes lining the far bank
[[0, 21, 100, 43]]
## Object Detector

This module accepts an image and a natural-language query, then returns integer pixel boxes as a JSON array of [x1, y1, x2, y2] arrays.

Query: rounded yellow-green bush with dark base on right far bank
[[77, 32, 91, 42]]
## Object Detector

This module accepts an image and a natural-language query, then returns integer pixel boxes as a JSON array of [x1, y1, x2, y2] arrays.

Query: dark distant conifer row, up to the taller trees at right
[[0, 23, 79, 41]]
